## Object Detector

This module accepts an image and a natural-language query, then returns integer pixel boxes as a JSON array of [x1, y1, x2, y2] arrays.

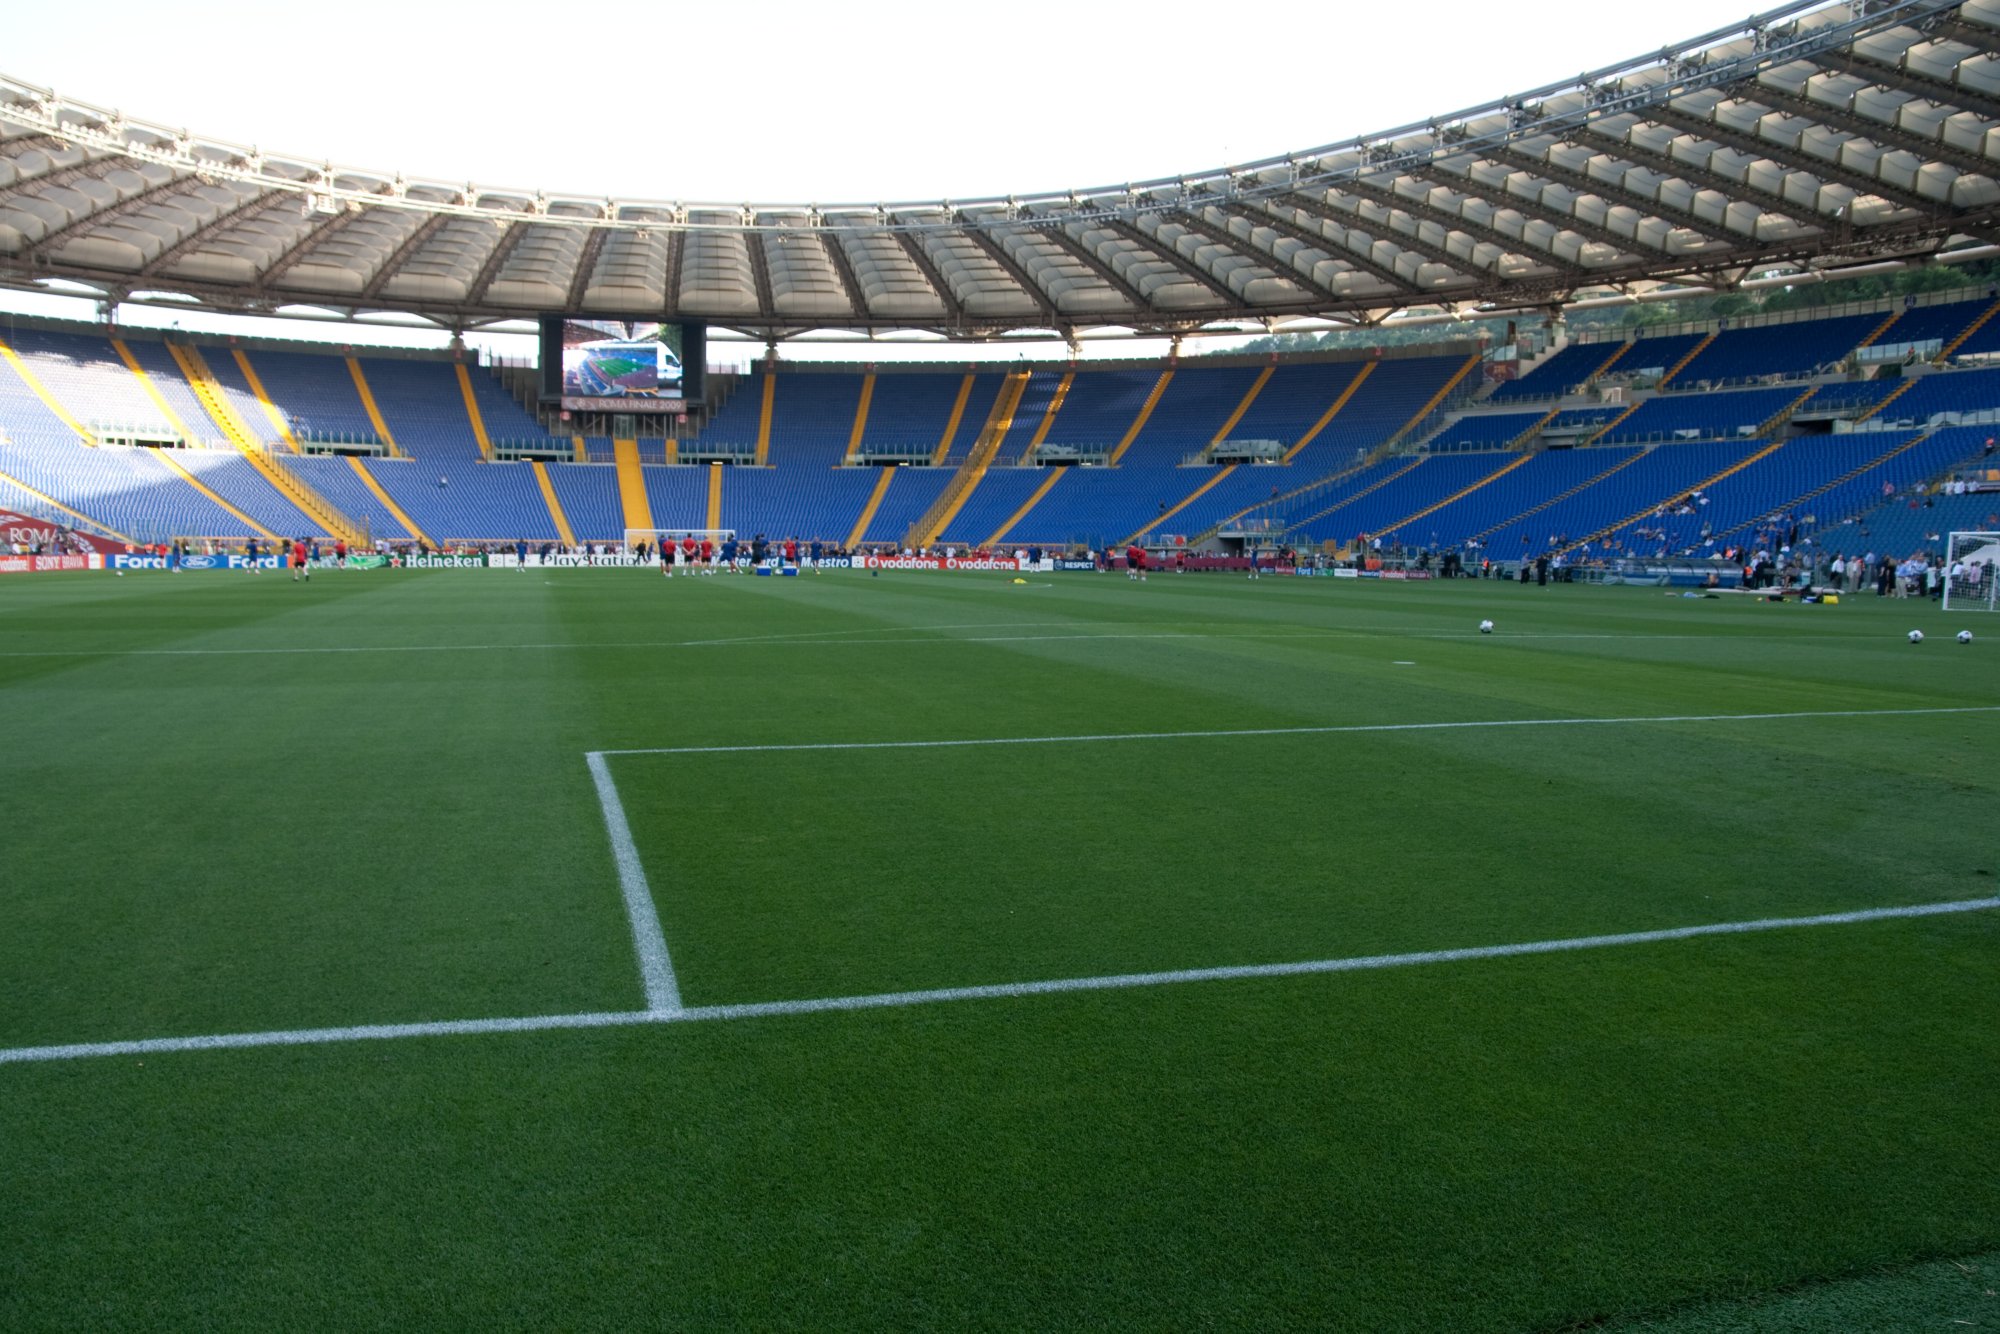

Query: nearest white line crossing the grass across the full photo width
[[0, 896, 2000, 1064]]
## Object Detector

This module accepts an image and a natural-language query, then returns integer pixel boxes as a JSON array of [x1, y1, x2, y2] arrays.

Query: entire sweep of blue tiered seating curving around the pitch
[[0, 300, 2000, 558]]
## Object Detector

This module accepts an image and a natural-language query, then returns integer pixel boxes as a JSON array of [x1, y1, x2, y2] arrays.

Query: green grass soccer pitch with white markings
[[0, 570, 2000, 1330]]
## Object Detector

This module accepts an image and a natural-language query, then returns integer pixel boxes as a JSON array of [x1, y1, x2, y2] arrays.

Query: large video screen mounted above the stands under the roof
[[542, 316, 708, 412]]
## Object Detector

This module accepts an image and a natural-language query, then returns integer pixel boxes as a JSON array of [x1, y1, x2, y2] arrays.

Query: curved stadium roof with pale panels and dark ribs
[[0, 0, 2000, 338]]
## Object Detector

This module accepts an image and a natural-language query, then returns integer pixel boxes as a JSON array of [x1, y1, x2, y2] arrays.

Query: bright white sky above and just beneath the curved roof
[[0, 0, 1776, 360]]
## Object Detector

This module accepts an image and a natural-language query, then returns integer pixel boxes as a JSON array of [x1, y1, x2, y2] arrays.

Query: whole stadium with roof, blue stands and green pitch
[[0, 0, 2000, 1332]]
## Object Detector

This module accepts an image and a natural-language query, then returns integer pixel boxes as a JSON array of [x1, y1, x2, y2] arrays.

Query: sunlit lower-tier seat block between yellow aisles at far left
[[0, 440, 256, 542]]
